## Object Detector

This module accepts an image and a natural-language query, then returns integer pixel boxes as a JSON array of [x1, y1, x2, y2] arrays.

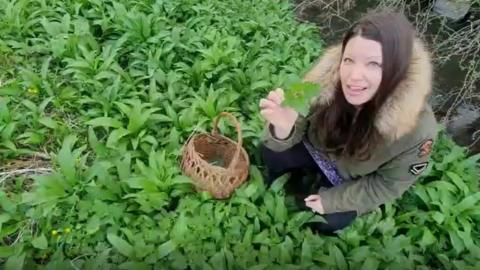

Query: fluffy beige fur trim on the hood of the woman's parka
[[304, 39, 433, 141]]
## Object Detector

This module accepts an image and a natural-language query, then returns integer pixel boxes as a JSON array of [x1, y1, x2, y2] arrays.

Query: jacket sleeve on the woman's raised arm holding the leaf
[[262, 115, 307, 152]]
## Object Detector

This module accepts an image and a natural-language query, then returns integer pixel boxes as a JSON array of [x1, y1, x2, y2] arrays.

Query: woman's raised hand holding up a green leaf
[[260, 88, 298, 138]]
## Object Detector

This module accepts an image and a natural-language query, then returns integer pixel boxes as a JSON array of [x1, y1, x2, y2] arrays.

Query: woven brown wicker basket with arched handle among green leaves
[[181, 112, 250, 199]]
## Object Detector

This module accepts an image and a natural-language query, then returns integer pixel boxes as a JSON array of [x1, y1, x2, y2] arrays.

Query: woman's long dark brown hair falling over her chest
[[316, 12, 414, 160]]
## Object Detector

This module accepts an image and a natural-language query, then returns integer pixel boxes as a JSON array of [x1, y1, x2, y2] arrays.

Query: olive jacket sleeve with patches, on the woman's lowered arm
[[319, 139, 436, 215]]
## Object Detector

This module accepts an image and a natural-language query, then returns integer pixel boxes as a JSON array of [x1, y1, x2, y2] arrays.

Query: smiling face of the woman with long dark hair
[[340, 36, 383, 106]]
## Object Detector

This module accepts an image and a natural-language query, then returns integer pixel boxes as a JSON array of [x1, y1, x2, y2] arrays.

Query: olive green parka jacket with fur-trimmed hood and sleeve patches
[[262, 39, 437, 215]]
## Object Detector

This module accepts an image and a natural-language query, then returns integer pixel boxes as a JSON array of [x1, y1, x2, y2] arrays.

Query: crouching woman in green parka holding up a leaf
[[260, 13, 437, 234]]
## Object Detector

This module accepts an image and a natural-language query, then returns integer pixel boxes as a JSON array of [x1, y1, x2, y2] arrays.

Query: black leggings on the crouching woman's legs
[[260, 142, 357, 235]]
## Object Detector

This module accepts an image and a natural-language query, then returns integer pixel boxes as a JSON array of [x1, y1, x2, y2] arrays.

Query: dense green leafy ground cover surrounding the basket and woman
[[0, 0, 480, 269]]
